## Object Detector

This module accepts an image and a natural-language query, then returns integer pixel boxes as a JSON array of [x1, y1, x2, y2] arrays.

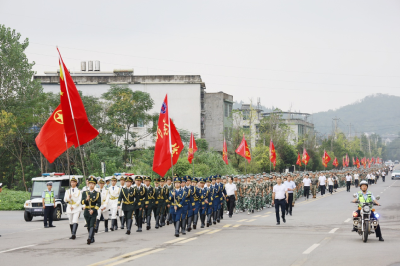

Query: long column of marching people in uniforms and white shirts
[[43, 166, 392, 245]]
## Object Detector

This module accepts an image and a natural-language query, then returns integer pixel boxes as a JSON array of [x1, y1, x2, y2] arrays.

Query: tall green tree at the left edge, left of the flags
[[0, 25, 44, 190]]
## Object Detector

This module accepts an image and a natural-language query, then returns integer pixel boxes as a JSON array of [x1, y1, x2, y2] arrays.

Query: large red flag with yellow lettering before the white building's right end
[[153, 95, 183, 176]]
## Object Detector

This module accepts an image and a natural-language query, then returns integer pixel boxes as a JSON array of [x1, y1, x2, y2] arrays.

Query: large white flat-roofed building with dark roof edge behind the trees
[[34, 62, 206, 148]]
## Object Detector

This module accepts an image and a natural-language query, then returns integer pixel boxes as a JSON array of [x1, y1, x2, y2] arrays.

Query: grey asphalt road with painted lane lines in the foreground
[[0, 171, 400, 266]]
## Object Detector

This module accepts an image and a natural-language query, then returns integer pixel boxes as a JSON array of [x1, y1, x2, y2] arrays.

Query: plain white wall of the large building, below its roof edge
[[42, 83, 201, 148]]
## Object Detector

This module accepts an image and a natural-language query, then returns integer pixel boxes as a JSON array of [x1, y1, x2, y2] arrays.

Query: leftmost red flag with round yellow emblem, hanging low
[[35, 104, 73, 163]]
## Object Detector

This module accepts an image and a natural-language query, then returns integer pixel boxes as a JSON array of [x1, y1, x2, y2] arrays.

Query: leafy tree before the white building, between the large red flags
[[102, 85, 154, 162]]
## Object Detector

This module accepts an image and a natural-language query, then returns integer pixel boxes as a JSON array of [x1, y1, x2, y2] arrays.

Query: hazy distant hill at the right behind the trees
[[313, 94, 400, 136]]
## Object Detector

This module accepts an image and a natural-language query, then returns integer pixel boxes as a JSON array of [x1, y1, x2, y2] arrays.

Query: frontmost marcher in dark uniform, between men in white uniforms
[[82, 177, 101, 245]]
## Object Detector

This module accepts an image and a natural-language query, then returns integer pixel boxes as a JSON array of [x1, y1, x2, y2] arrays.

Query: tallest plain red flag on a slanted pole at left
[[57, 48, 99, 147]]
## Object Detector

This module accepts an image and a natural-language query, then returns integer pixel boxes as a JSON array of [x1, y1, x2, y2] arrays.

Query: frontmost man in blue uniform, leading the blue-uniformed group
[[169, 177, 186, 237]]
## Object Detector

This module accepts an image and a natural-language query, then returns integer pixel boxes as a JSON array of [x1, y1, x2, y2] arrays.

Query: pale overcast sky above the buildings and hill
[[0, 0, 400, 113]]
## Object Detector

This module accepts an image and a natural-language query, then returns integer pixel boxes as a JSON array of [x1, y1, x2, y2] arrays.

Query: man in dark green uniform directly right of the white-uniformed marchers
[[118, 176, 136, 235]]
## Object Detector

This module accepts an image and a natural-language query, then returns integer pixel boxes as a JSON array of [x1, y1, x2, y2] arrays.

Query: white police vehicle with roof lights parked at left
[[24, 173, 83, 222]]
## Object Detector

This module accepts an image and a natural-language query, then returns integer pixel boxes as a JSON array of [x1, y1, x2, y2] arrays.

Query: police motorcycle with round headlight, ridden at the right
[[352, 194, 380, 243]]
